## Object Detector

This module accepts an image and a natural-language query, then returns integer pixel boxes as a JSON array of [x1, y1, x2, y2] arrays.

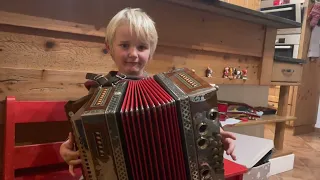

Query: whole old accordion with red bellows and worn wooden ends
[[66, 68, 224, 180]]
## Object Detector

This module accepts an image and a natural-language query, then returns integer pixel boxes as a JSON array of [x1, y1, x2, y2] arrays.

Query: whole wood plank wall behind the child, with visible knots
[[0, 0, 265, 173]]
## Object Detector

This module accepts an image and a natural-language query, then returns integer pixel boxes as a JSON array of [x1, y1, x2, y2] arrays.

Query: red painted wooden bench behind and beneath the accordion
[[3, 96, 246, 180]]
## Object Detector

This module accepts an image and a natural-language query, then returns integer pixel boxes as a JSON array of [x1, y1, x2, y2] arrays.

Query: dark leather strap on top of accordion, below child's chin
[[86, 71, 147, 87]]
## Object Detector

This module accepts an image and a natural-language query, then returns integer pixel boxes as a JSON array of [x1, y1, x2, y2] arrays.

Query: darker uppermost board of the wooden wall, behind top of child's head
[[0, 0, 264, 57]]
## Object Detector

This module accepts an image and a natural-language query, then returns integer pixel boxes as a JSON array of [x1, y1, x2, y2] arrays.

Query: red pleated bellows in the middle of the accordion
[[120, 78, 187, 180]]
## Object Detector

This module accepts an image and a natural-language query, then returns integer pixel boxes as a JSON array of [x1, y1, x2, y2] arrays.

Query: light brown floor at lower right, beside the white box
[[264, 125, 320, 180]]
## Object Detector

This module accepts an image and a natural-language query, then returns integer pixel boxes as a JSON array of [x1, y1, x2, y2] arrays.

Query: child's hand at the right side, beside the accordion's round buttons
[[220, 128, 237, 160]]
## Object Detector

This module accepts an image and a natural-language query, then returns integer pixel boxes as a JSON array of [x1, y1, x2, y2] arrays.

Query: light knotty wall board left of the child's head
[[0, 25, 114, 71]]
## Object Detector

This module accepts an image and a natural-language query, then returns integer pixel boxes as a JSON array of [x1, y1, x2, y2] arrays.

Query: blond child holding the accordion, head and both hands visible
[[60, 8, 236, 176]]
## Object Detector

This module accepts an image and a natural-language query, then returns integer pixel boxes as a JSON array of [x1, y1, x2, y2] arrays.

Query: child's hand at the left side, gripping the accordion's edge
[[60, 133, 81, 176]]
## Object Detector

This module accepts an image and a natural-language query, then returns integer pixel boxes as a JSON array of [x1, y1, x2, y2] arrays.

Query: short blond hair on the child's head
[[105, 8, 158, 58]]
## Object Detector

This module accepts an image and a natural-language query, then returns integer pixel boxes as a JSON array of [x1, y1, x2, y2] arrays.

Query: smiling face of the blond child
[[111, 25, 150, 76]]
